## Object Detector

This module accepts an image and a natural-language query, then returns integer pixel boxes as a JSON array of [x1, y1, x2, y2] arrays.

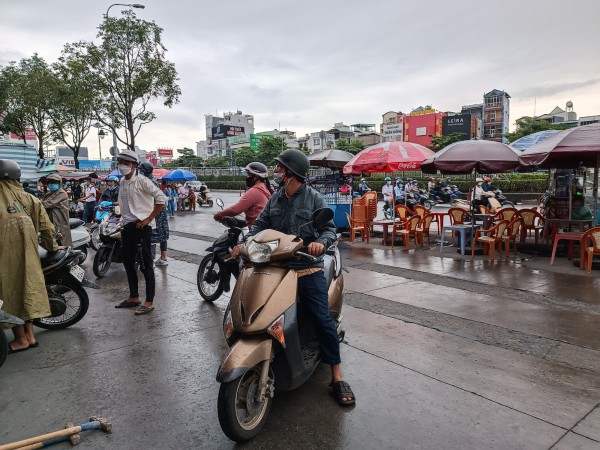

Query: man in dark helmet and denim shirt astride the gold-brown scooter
[[232, 149, 355, 405]]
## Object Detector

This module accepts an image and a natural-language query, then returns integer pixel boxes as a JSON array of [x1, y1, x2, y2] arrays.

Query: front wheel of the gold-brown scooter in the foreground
[[217, 363, 273, 442]]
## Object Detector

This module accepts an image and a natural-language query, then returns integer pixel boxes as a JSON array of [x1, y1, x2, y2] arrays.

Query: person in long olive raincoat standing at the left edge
[[0, 159, 58, 353]]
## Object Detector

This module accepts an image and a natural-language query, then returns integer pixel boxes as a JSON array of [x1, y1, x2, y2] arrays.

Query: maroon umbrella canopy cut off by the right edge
[[519, 123, 600, 169]]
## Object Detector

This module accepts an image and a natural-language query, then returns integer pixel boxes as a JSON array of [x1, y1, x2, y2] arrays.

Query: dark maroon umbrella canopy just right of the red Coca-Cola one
[[421, 140, 520, 174]]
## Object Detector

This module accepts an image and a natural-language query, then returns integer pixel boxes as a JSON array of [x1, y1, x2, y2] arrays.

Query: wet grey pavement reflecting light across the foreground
[[0, 193, 600, 449]]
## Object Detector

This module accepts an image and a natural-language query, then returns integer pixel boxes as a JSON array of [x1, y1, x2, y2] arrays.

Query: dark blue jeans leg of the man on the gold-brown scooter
[[298, 270, 341, 366]]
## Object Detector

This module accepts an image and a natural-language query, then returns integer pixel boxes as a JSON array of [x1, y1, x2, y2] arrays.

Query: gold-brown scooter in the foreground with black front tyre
[[217, 208, 344, 442]]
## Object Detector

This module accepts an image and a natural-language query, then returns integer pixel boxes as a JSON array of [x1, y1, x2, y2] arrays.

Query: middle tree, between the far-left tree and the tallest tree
[[49, 45, 100, 169]]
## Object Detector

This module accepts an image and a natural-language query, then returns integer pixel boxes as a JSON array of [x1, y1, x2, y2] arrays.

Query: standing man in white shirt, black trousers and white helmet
[[115, 150, 167, 315]]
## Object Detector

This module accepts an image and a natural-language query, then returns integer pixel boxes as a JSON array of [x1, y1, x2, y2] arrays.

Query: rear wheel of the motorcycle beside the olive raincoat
[[33, 281, 90, 330]]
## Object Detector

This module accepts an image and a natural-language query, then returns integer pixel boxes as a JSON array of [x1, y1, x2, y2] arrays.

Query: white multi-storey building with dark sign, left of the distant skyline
[[196, 111, 254, 159]]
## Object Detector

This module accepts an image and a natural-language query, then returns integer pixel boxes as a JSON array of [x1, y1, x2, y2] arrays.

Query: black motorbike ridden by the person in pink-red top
[[196, 198, 246, 302]]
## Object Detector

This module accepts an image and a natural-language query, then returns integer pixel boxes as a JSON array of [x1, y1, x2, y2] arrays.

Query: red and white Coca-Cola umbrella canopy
[[344, 141, 435, 175]]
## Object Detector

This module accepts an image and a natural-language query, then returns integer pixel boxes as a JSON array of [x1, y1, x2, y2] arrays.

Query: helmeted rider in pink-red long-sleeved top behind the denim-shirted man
[[213, 162, 273, 228]]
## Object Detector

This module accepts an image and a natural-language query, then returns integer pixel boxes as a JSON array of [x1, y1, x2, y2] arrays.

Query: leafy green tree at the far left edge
[[0, 53, 56, 159]]
